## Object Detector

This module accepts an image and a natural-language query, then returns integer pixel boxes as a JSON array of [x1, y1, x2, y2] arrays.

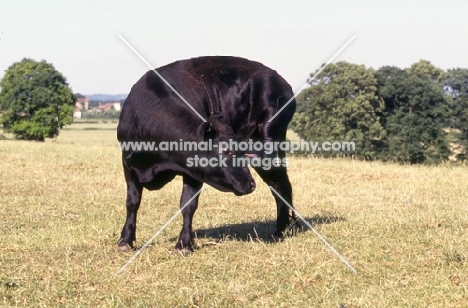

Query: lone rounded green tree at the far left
[[0, 59, 74, 141]]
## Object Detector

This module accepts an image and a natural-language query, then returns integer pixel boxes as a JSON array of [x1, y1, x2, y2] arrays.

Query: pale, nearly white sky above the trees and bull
[[0, 0, 468, 94]]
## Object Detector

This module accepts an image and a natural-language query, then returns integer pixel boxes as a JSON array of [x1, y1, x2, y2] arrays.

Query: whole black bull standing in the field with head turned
[[117, 57, 296, 253]]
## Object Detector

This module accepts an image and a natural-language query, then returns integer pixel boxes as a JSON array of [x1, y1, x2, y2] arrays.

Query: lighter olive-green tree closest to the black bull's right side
[[291, 62, 385, 159]]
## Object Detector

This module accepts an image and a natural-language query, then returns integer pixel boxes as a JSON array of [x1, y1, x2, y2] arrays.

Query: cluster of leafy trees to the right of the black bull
[[291, 60, 468, 164]]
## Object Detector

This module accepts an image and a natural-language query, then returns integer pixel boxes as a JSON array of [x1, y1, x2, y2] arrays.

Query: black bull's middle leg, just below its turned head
[[175, 175, 203, 254]]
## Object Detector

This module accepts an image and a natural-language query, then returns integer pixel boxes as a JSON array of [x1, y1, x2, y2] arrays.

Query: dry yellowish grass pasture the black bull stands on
[[0, 121, 468, 308]]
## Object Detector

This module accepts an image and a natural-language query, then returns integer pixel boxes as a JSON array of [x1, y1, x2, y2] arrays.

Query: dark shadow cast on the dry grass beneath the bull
[[192, 215, 345, 243]]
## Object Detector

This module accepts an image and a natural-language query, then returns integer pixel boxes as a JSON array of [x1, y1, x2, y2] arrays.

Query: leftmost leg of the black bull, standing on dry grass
[[116, 166, 143, 252]]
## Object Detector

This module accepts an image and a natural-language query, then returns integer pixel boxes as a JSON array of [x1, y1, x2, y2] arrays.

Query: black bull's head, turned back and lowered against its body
[[190, 116, 255, 195]]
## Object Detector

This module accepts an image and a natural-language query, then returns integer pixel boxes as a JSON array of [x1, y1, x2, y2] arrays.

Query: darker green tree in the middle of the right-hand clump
[[376, 61, 450, 163]]
